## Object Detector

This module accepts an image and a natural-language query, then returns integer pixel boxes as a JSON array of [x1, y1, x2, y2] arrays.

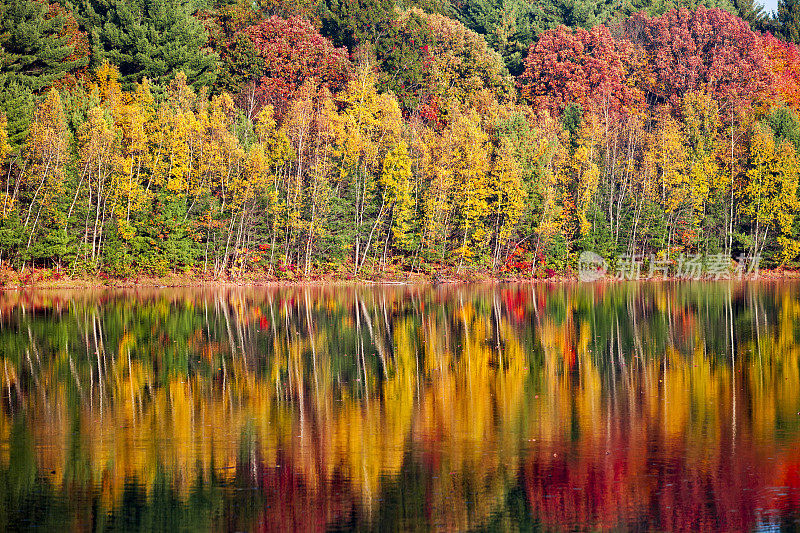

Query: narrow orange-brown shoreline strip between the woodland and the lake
[[0, 269, 800, 292]]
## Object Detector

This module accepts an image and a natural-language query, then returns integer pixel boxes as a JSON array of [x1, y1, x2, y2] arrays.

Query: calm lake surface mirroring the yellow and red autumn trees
[[0, 282, 800, 531]]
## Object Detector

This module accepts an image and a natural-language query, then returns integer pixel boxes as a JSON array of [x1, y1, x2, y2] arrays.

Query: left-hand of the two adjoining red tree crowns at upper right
[[519, 26, 640, 114]]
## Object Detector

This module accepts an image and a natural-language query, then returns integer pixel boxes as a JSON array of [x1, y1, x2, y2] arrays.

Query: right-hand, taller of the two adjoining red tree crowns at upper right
[[624, 6, 770, 113]]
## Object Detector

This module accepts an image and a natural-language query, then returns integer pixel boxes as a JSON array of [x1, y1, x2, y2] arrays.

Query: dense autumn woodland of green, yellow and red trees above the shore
[[0, 0, 800, 278]]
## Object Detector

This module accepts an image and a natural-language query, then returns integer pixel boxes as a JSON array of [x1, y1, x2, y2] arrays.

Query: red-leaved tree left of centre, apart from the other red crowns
[[239, 16, 350, 117]]
